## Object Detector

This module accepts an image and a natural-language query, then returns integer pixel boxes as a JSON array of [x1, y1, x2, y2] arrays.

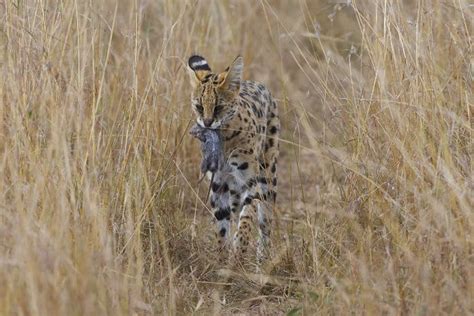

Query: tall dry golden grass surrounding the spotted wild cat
[[0, 0, 474, 315]]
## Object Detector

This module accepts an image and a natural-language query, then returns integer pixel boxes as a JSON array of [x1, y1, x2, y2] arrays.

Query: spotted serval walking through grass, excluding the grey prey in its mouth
[[188, 55, 280, 261]]
